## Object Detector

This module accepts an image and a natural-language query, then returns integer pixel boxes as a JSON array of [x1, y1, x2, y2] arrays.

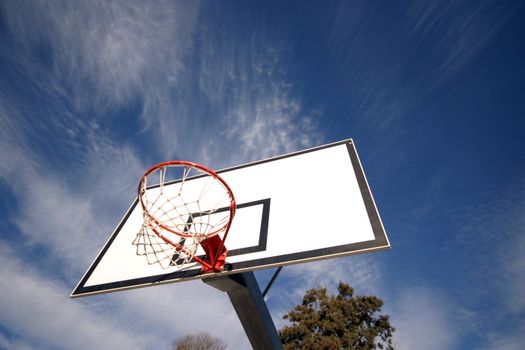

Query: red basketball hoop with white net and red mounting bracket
[[133, 160, 236, 272]]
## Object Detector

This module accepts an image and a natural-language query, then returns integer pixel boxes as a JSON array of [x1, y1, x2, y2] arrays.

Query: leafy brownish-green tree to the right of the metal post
[[279, 282, 395, 350]]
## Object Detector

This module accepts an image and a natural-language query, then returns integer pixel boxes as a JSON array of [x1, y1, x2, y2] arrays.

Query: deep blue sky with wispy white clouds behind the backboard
[[0, 0, 525, 349]]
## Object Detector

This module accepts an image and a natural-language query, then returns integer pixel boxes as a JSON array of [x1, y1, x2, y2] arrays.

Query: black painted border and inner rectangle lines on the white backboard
[[71, 139, 390, 297]]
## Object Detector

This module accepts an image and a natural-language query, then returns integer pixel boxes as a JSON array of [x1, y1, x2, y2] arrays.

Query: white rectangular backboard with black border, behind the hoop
[[71, 139, 390, 297]]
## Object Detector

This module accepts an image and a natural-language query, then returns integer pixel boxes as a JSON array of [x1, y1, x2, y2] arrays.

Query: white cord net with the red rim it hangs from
[[133, 161, 235, 268]]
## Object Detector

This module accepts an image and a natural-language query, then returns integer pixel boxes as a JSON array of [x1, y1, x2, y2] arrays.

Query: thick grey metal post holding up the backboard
[[202, 272, 283, 350]]
